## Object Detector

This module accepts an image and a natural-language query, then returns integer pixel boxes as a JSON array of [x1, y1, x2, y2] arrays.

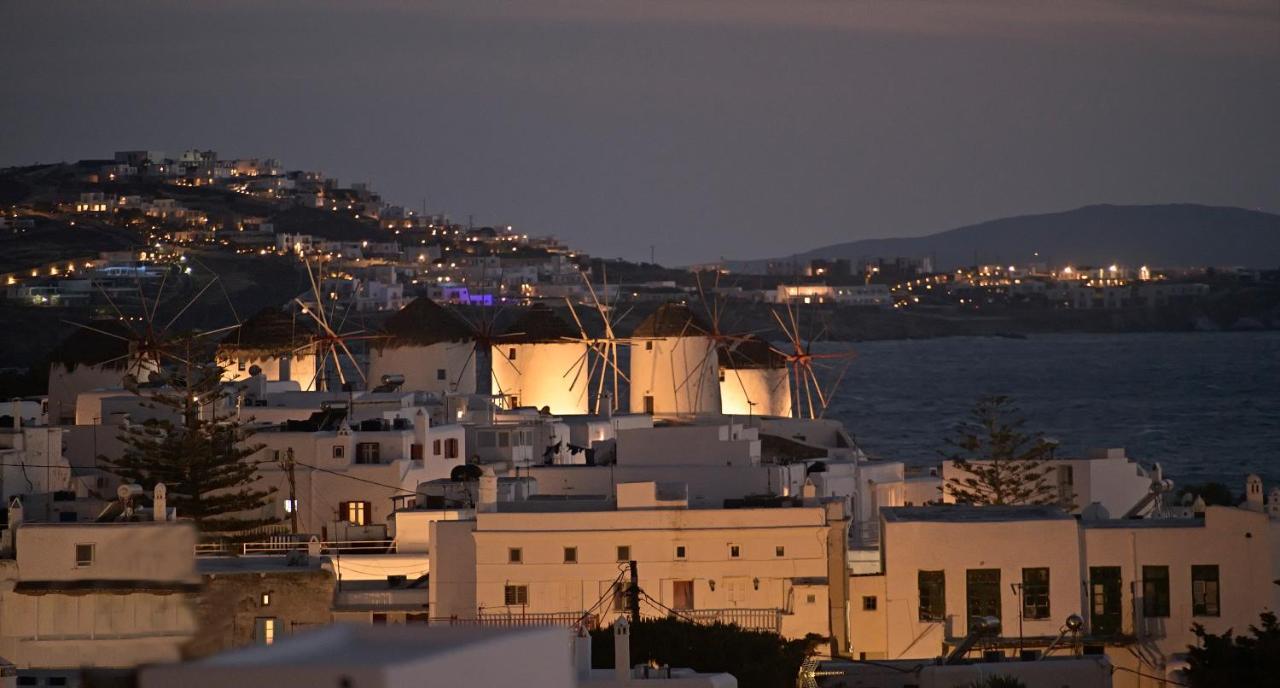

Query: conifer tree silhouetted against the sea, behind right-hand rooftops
[[942, 395, 1074, 509]]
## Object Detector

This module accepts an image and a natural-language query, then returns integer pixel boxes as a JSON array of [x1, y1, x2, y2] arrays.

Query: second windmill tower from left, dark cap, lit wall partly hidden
[[216, 308, 319, 391]]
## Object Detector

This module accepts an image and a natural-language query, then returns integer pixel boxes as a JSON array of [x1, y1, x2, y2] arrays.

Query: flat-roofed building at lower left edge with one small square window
[[0, 505, 200, 685]]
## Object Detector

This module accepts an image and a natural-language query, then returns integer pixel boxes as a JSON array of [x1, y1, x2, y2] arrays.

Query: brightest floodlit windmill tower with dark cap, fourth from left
[[490, 303, 589, 416]]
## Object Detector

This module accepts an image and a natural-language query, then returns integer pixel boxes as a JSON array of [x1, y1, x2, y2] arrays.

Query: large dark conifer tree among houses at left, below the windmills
[[99, 352, 276, 538]]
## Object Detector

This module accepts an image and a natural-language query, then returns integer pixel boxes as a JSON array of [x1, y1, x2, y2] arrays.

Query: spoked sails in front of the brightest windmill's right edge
[[563, 264, 631, 413]]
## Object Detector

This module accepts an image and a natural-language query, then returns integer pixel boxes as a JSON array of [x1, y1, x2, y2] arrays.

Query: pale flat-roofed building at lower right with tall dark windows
[[849, 483, 1280, 685]]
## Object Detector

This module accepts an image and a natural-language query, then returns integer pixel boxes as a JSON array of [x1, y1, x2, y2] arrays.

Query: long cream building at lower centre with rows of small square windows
[[430, 476, 847, 647]]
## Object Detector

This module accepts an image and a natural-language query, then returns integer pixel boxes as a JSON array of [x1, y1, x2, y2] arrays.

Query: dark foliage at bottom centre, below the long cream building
[[591, 618, 823, 688]]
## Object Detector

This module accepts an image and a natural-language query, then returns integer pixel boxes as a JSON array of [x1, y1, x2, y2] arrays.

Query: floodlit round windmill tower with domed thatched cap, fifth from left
[[630, 302, 721, 416]]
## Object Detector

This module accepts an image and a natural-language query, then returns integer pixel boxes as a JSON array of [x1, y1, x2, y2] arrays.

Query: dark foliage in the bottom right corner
[[1187, 611, 1280, 688]]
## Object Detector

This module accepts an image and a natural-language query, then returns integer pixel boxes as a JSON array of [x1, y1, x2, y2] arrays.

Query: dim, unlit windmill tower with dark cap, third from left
[[369, 297, 476, 394]]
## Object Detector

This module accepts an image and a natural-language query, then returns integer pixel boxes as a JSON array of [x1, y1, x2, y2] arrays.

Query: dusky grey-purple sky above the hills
[[0, 0, 1280, 265]]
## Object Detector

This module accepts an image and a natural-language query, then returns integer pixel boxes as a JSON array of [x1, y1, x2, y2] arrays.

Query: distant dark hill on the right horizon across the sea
[[730, 205, 1280, 272]]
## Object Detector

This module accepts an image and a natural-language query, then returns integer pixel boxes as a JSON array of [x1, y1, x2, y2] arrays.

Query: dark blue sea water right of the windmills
[[820, 332, 1280, 483]]
